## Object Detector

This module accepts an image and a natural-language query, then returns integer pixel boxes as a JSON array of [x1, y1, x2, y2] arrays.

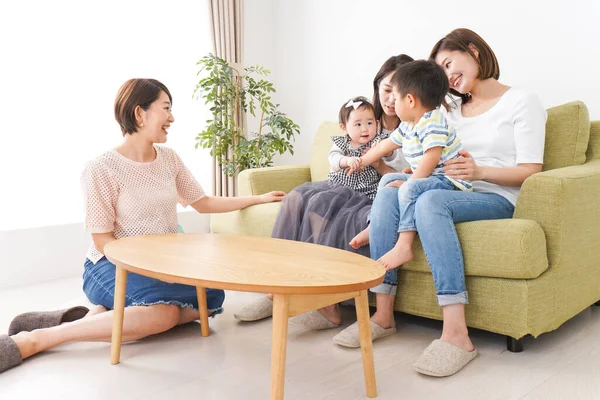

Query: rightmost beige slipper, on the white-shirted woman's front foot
[[414, 339, 477, 377]]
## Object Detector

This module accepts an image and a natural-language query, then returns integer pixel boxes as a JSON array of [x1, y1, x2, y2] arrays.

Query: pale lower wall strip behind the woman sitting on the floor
[[0, 211, 210, 289]]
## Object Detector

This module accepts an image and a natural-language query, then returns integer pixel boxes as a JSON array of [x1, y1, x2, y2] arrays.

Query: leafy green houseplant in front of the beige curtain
[[194, 54, 300, 176]]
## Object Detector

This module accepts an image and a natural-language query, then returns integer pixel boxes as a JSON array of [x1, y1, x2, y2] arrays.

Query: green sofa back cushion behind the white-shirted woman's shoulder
[[543, 101, 590, 171]]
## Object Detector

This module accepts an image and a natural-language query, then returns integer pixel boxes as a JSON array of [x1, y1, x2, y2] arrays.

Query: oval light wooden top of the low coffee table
[[104, 233, 385, 294]]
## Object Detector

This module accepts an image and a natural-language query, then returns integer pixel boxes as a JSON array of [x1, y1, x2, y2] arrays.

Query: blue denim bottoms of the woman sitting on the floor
[[83, 257, 225, 315]]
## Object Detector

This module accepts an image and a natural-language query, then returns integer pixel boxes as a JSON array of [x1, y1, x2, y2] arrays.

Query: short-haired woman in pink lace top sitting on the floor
[[0, 79, 285, 372]]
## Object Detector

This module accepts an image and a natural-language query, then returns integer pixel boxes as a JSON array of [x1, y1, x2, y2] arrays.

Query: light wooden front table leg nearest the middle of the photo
[[271, 294, 290, 400]]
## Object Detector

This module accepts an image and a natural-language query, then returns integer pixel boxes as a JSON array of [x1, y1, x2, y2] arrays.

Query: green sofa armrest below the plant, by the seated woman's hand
[[238, 165, 310, 196]]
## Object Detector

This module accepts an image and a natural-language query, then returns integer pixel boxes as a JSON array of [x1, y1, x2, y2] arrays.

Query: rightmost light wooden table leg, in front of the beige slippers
[[355, 290, 377, 398]]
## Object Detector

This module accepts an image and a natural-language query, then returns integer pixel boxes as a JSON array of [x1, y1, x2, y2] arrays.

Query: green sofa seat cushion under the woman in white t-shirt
[[400, 219, 548, 279]]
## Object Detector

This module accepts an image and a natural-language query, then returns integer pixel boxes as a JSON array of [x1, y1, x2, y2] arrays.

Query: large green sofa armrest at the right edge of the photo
[[514, 160, 600, 268]]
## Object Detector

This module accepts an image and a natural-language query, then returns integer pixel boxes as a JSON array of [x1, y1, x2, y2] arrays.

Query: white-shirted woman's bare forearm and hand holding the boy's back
[[444, 150, 542, 187]]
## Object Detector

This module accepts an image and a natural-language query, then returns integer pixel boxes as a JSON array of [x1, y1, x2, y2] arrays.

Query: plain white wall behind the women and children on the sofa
[[245, 0, 600, 164]]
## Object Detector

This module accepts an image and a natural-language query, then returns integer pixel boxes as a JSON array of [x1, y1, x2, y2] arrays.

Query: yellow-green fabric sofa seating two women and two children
[[211, 102, 600, 351]]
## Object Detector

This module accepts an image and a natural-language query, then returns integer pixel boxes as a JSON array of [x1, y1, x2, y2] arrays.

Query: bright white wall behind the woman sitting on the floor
[[0, 0, 212, 288]]
